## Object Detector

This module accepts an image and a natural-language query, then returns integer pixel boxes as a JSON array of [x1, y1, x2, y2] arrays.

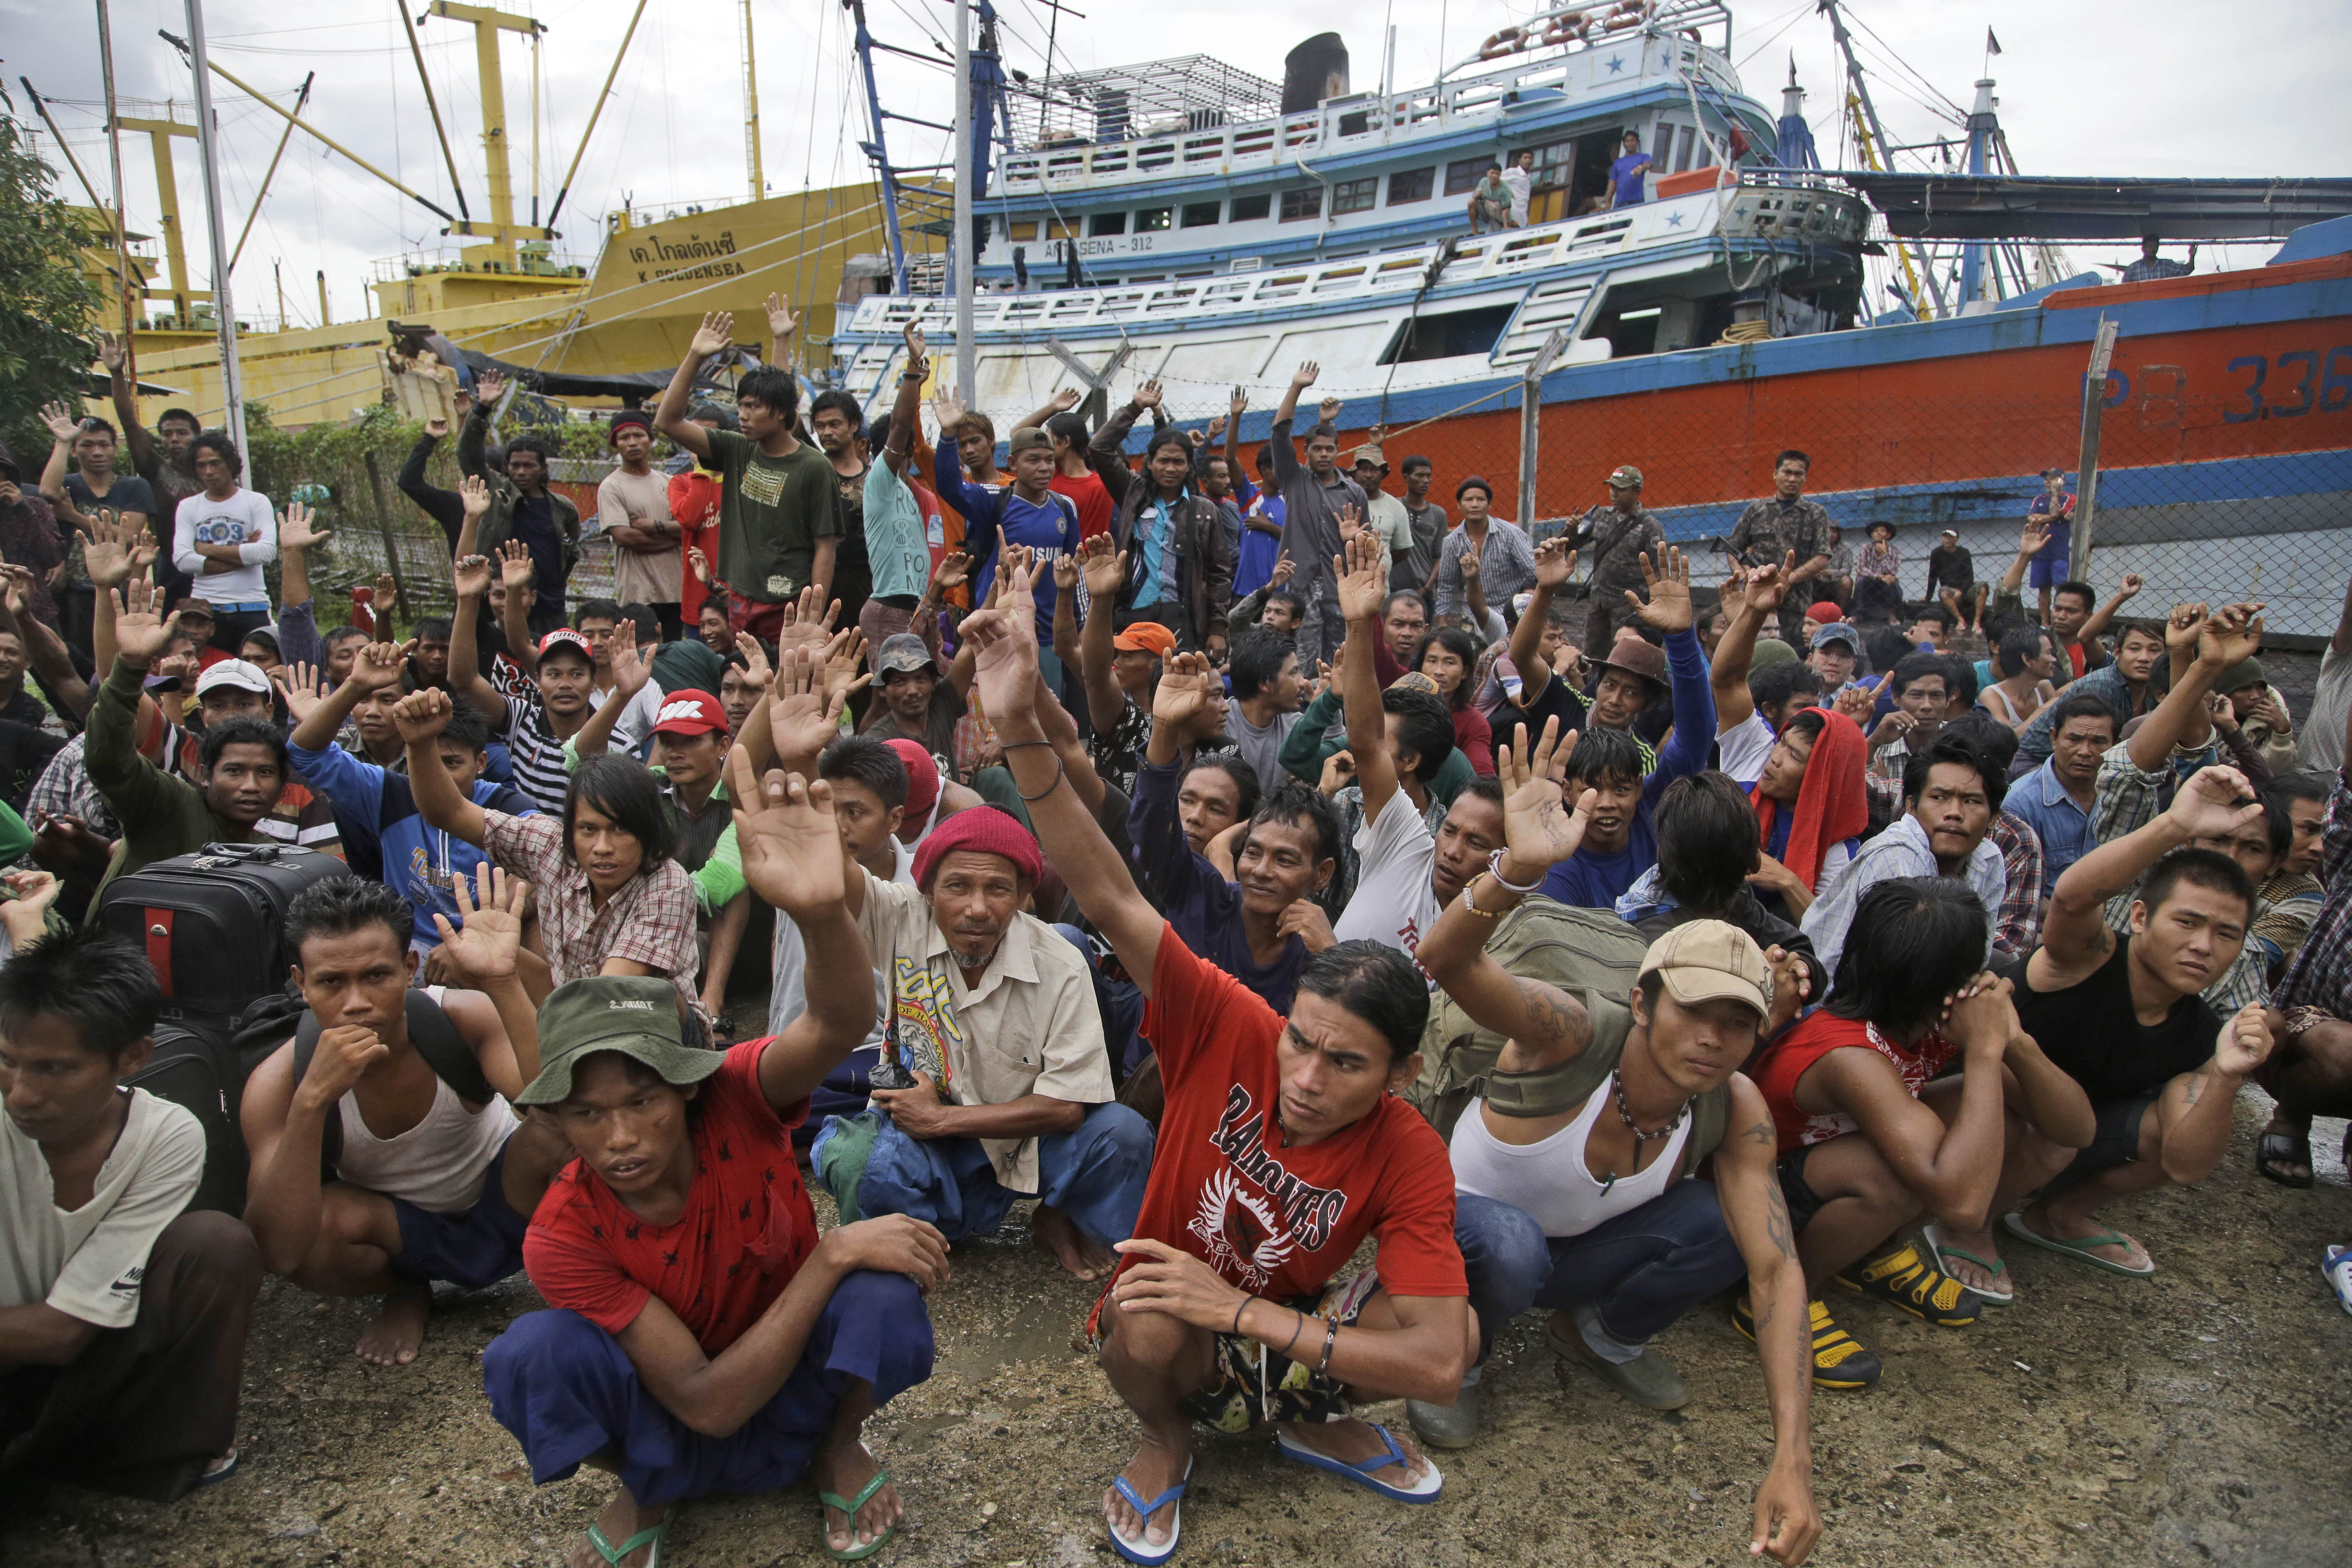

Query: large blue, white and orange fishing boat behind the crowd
[[833, 0, 2352, 635]]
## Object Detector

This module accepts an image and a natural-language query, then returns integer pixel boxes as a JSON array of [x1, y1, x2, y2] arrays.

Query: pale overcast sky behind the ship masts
[[0, 0, 2352, 324]]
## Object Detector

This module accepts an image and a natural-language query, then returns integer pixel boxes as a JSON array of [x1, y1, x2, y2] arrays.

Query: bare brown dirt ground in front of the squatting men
[[0, 1091, 2352, 1568]]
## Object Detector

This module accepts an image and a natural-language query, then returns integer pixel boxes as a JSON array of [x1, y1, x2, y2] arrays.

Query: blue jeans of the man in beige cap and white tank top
[[1454, 1180, 1748, 1382]]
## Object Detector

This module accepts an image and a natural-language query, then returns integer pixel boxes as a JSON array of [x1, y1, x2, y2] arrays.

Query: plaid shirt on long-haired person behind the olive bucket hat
[[482, 811, 701, 1013]]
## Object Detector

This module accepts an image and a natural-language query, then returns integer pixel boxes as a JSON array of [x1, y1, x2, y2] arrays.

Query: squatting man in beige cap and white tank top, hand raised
[[1406, 724, 1820, 1563]]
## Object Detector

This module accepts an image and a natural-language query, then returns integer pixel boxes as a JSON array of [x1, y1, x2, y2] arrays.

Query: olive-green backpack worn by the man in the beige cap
[[1404, 896, 1731, 1161]]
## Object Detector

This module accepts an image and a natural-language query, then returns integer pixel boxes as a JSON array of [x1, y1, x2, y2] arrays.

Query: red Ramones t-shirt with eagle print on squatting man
[[1136, 929, 1470, 1300]]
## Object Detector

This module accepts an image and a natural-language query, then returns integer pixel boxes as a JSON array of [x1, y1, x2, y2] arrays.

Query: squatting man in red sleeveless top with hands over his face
[[1734, 877, 2091, 1389]]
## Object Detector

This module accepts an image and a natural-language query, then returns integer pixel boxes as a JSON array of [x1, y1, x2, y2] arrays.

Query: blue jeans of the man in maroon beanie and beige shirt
[[811, 1105, 1152, 1246]]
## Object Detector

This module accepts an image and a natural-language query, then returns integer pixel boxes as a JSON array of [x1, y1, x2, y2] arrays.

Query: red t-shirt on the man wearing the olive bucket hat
[[522, 1039, 816, 1357]]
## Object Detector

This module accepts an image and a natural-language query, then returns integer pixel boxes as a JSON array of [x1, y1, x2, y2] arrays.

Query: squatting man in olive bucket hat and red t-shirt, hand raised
[[482, 764, 948, 1563]]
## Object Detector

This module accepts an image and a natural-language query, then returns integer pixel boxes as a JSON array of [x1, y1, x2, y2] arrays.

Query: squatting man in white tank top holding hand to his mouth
[[238, 867, 572, 1366]]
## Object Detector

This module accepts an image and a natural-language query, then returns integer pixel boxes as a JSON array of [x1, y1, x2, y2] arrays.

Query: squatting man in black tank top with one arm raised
[[1994, 769, 2272, 1274]]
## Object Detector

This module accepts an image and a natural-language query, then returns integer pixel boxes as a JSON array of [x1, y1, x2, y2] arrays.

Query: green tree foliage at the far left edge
[[0, 115, 103, 463]]
